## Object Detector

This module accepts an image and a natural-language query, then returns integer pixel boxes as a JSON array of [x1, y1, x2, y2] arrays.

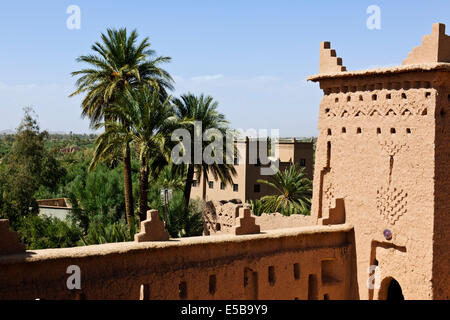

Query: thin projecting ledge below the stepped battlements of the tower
[[306, 62, 450, 82]]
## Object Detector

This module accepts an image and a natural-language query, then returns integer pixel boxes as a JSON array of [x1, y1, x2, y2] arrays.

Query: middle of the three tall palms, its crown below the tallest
[[93, 85, 179, 221]]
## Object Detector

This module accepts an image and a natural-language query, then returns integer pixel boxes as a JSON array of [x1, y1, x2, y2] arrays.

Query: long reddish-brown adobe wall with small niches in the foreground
[[0, 225, 355, 299]]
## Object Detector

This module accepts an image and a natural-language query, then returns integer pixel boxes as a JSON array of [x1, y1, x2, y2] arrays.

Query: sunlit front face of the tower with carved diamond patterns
[[312, 72, 440, 299]]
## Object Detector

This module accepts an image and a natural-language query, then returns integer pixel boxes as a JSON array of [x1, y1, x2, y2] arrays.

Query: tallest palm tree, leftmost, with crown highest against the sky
[[70, 28, 173, 226]]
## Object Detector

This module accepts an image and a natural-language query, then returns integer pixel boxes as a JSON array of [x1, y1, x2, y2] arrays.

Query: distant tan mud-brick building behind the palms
[[191, 138, 314, 202]]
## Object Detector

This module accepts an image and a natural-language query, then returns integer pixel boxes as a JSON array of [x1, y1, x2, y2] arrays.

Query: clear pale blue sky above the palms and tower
[[0, 0, 450, 136]]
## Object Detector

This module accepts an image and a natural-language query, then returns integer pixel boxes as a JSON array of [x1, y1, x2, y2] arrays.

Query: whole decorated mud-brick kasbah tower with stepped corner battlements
[[308, 23, 450, 299]]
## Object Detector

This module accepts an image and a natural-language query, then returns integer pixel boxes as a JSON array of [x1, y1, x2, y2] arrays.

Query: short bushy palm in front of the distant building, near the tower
[[258, 165, 312, 215]]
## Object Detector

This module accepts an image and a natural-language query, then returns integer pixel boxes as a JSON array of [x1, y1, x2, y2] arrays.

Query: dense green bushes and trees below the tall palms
[[0, 110, 203, 249]]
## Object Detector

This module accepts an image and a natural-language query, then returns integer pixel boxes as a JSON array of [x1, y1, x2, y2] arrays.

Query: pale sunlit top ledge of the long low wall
[[0, 224, 353, 265]]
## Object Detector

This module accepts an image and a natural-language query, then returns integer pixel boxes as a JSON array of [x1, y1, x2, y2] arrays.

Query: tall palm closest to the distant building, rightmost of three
[[173, 93, 236, 208]]
